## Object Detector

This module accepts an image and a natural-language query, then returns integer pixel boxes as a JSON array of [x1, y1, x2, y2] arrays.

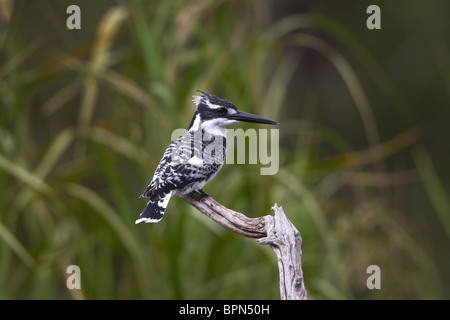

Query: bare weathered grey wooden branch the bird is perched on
[[179, 192, 306, 300]]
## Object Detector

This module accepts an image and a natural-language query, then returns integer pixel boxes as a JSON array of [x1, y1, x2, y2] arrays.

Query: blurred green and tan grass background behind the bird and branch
[[0, 0, 450, 299]]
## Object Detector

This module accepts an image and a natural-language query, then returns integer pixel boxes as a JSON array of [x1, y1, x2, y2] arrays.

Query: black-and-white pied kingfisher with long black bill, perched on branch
[[136, 90, 278, 224]]
